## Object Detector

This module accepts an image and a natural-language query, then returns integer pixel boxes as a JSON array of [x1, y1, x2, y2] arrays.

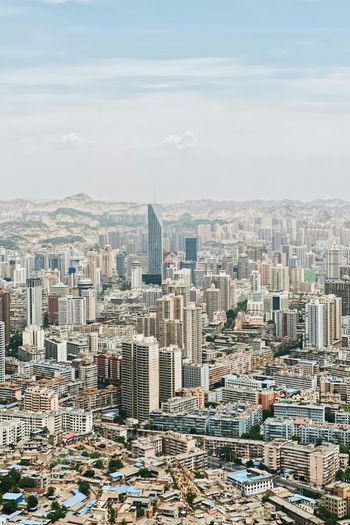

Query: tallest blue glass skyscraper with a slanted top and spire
[[148, 204, 163, 284]]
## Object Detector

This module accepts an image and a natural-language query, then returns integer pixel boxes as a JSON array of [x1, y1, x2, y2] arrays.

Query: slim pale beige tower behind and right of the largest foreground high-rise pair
[[183, 303, 202, 365]]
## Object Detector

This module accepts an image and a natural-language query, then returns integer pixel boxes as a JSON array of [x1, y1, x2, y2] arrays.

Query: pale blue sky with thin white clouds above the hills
[[0, 0, 350, 202]]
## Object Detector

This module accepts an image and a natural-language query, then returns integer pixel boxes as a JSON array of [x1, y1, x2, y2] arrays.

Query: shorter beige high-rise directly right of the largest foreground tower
[[159, 346, 182, 403]]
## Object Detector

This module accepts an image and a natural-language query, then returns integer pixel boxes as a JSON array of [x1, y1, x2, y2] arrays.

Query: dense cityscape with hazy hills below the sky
[[0, 194, 350, 525]]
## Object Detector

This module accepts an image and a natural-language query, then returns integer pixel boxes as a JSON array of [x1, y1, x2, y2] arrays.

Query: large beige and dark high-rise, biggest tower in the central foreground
[[122, 335, 159, 421]]
